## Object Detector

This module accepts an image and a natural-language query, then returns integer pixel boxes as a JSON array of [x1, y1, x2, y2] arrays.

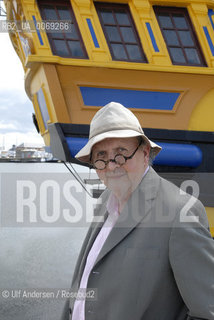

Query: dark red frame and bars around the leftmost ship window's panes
[[37, 0, 88, 59]]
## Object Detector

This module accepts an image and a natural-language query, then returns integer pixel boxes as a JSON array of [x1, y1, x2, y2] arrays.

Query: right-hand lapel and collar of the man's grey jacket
[[95, 168, 160, 265]]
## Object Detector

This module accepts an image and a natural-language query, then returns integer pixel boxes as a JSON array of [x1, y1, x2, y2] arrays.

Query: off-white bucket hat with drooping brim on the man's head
[[75, 102, 161, 163]]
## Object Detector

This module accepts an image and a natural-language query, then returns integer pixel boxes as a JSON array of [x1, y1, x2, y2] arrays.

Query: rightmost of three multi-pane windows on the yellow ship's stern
[[154, 7, 206, 66]]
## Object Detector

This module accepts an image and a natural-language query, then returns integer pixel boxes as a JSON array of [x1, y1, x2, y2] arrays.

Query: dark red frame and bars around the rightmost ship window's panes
[[153, 6, 207, 67]]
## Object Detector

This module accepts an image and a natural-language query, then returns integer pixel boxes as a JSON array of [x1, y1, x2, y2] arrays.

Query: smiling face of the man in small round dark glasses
[[92, 137, 150, 196]]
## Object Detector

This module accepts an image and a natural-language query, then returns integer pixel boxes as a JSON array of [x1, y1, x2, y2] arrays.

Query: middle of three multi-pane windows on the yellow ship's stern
[[95, 3, 147, 62]]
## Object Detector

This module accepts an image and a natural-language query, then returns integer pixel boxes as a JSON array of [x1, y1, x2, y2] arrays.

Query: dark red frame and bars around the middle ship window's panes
[[94, 2, 148, 63]]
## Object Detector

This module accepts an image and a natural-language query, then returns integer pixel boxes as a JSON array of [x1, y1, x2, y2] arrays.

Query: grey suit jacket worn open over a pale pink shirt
[[62, 168, 214, 320]]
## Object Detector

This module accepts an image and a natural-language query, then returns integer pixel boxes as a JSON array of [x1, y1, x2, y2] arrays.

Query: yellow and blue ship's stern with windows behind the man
[[5, 0, 214, 234]]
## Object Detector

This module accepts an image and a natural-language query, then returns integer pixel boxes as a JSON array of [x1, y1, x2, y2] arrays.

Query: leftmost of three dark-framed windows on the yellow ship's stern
[[38, 0, 87, 58]]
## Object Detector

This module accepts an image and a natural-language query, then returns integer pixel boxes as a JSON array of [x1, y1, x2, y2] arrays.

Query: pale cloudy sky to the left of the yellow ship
[[0, 17, 43, 150]]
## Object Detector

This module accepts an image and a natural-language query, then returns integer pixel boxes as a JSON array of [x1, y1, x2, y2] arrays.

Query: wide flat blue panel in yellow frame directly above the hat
[[80, 87, 180, 111]]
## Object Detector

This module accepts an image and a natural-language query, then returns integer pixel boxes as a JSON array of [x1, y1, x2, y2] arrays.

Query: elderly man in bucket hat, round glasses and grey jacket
[[63, 102, 214, 320]]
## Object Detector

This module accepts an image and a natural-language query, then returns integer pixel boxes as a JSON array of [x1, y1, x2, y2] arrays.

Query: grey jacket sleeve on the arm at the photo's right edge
[[169, 197, 214, 320]]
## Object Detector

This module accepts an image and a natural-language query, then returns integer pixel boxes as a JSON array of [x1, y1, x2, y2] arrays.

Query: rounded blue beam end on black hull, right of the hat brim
[[154, 142, 203, 168]]
